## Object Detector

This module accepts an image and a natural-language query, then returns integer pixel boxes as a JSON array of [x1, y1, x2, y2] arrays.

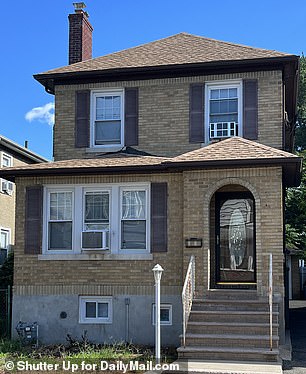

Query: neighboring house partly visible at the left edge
[[0, 135, 47, 268]]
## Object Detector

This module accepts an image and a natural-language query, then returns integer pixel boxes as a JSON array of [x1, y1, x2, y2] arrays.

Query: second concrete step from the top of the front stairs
[[192, 299, 278, 312]]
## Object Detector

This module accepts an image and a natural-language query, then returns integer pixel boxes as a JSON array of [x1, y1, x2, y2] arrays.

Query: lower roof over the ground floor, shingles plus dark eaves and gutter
[[0, 137, 301, 186]]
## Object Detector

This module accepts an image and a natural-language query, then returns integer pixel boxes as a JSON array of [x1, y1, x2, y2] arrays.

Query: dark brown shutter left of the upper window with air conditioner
[[189, 84, 205, 143]]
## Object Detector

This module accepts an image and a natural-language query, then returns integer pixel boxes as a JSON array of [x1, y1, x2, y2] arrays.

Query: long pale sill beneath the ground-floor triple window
[[38, 251, 153, 261]]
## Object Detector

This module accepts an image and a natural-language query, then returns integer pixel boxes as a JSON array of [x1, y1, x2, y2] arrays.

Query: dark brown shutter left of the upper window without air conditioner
[[75, 90, 90, 148]]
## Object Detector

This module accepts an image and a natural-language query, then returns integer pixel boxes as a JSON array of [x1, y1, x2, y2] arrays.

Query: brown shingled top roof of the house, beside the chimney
[[35, 32, 290, 77]]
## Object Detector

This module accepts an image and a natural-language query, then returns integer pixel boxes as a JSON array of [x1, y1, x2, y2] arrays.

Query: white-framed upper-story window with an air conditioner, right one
[[205, 82, 242, 142]]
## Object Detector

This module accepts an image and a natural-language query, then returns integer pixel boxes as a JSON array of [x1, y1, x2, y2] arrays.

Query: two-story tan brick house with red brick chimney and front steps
[[1, 3, 301, 361]]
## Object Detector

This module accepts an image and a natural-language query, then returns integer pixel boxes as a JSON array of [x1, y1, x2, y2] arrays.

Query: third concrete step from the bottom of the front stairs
[[187, 321, 278, 335]]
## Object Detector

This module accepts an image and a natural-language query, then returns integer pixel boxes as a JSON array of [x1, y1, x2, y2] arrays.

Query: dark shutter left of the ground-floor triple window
[[24, 186, 43, 255]]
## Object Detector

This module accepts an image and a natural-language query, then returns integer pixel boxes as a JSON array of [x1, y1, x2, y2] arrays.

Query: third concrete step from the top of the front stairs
[[189, 310, 279, 323]]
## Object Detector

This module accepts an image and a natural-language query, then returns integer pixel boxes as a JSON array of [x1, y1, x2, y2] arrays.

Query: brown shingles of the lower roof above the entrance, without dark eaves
[[0, 137, 300, 177]]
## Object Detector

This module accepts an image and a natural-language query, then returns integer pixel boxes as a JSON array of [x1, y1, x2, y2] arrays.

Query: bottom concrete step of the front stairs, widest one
[[177, 346, 279, 362]]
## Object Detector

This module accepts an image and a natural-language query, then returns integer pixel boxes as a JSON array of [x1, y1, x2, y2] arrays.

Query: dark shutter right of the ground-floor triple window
[[151, 183, 168, 252]]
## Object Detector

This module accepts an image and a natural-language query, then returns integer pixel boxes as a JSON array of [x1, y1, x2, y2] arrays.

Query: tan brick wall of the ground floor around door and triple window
[[14, 167, 283, 295]]
